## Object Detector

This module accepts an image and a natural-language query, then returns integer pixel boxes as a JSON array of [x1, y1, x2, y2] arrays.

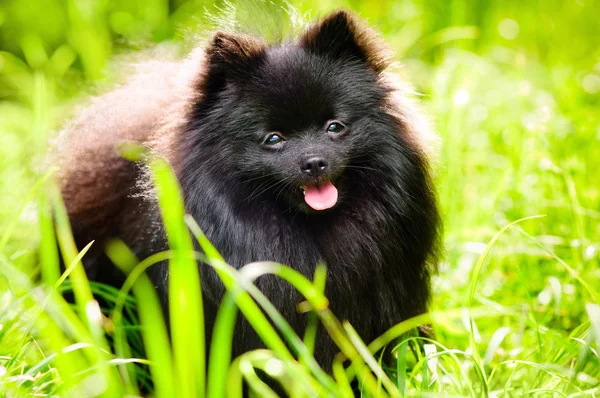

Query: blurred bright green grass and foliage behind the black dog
[[0, 0, 600, 394]]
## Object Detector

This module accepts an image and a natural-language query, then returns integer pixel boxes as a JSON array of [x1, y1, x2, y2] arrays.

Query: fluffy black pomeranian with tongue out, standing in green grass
[[60, 11, 440, 367]]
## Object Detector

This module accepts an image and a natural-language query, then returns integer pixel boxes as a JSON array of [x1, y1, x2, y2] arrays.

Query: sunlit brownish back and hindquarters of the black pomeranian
[[55, 54, 201, 276]]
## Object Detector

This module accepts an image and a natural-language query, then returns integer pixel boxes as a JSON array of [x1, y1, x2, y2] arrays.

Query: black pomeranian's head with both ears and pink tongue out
[[192, 11, 412, 212]]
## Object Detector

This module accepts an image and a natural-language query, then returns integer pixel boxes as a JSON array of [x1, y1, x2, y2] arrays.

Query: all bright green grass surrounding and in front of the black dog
[[0, 0, 600, 397]]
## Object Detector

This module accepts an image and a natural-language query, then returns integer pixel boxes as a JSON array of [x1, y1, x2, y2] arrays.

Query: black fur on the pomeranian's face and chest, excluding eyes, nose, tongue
[[59, 12, 439, 374]]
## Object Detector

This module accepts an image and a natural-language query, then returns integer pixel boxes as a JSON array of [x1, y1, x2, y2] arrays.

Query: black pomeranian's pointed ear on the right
[[300, 10, 389, 73]]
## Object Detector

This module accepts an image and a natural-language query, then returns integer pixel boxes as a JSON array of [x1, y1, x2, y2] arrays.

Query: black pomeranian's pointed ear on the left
[[205, 32, 267, 91]]
